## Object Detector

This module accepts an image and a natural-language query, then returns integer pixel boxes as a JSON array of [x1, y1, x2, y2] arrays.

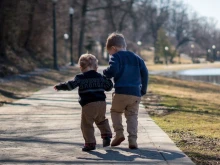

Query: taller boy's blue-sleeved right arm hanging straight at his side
[[140, 60, 148, 96]]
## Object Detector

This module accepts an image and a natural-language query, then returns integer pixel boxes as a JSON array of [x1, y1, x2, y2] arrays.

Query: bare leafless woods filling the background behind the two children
[[0, 0, 220, 77]]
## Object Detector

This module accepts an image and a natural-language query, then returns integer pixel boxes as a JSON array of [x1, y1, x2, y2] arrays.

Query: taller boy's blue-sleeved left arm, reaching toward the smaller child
[[103, 56, 119, 78]]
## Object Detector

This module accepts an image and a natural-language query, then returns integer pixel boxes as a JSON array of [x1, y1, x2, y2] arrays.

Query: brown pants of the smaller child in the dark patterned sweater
[[81, 101, 112, 144]]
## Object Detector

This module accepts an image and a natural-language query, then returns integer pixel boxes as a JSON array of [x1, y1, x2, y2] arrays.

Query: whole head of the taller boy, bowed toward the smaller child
[[106, 32, 127, 55]]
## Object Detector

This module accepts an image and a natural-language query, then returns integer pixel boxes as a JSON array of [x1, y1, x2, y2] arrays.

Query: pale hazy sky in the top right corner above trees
[[183, 0, 220, 28]]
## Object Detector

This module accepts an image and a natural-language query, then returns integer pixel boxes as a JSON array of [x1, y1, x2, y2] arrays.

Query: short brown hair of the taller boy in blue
[[106, 32, 127, 50]]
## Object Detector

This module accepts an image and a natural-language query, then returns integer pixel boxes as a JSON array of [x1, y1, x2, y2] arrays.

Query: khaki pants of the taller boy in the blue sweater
[[111, 94, 141, 140]]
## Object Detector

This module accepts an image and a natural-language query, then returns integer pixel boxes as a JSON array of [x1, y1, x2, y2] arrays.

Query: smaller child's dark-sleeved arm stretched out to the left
[[54, 76, 79, 91]]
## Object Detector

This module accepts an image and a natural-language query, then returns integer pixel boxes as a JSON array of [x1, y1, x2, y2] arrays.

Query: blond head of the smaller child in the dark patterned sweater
[[78, 54, 98, 72]]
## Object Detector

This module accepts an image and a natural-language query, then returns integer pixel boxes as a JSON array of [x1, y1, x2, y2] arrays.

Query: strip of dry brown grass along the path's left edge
[[0, 67, 79, 106]]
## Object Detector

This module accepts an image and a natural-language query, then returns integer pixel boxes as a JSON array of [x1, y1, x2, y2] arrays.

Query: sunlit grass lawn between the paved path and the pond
[[144, 76, 220, 165]]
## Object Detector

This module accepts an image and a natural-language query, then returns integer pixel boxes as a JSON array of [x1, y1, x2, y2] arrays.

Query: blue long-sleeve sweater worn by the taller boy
[[103, 51, 148, 96]]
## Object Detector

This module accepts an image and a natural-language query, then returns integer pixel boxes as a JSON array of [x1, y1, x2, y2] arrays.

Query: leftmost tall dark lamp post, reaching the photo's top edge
[[52, 0, 58, 70]]
